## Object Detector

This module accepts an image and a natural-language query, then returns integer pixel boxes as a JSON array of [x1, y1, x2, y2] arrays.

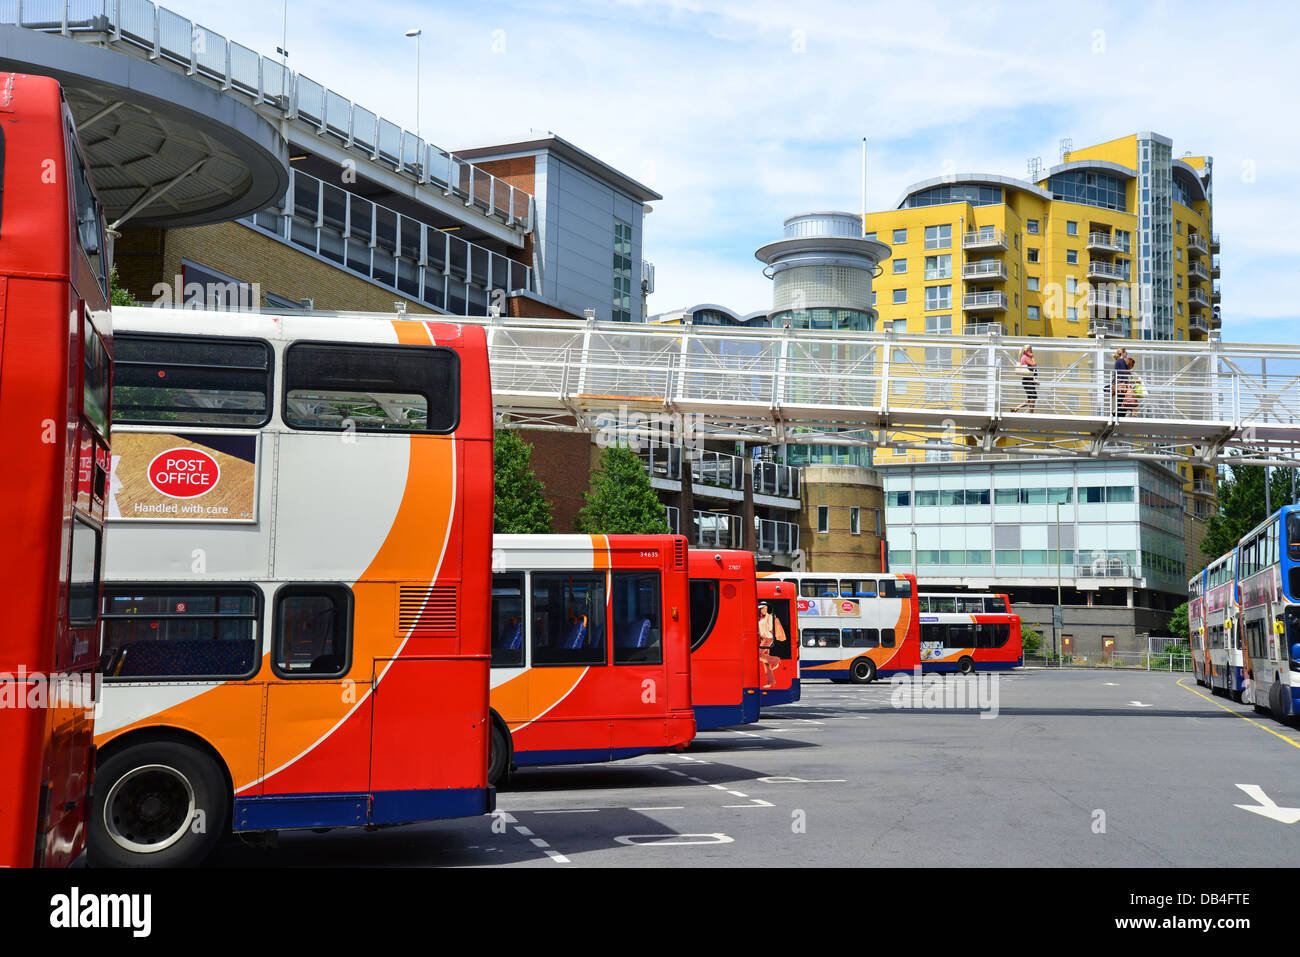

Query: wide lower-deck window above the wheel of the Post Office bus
[[100, 585, 260, 680]]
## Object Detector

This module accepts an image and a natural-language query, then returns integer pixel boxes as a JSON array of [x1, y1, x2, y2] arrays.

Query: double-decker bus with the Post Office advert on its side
[[88, 309, 493, 865]]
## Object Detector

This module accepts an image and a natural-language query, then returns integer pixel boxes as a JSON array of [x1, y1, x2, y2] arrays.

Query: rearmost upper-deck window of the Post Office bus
[[283, 342, 460, 434]]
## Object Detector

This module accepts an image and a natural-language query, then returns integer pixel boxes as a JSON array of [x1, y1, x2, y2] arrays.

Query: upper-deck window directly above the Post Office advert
[[113, 333, 270, 428]]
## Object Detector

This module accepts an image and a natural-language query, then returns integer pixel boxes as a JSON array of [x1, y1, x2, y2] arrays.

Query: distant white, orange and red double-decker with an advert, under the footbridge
[[770, 572, 920, 684]]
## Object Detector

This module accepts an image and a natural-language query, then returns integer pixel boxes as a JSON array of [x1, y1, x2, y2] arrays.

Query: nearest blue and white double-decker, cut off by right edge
[[1236, 505, 1300, 722]]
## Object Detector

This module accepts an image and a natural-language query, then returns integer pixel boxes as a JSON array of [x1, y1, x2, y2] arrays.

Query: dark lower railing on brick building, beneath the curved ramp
[[243, 170, 533, 316]]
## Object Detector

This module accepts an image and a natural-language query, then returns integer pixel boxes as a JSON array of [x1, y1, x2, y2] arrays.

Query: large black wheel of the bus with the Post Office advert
[[86, 741, 230, 867]]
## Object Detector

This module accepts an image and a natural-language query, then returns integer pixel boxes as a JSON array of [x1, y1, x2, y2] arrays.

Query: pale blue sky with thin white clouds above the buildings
[[164, 0, 1300, 342]]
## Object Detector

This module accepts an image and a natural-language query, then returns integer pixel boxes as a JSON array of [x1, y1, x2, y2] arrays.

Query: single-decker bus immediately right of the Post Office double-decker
[[489, 530, 696, 783]]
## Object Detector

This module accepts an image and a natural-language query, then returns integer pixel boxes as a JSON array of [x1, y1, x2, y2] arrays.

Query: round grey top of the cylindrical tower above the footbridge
[[754, 212, 892, 332]]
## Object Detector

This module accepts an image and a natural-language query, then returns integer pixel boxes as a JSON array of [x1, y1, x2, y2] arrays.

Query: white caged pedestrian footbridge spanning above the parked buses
[[473, 317, 1300, 464]]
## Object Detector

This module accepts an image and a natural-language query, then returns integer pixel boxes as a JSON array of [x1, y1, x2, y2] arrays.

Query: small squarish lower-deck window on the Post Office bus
[[272, 585, 352, 677]]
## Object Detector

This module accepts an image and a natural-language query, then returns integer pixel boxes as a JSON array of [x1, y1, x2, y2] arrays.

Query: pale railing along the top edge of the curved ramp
[[0, 0, 533, 229]]
